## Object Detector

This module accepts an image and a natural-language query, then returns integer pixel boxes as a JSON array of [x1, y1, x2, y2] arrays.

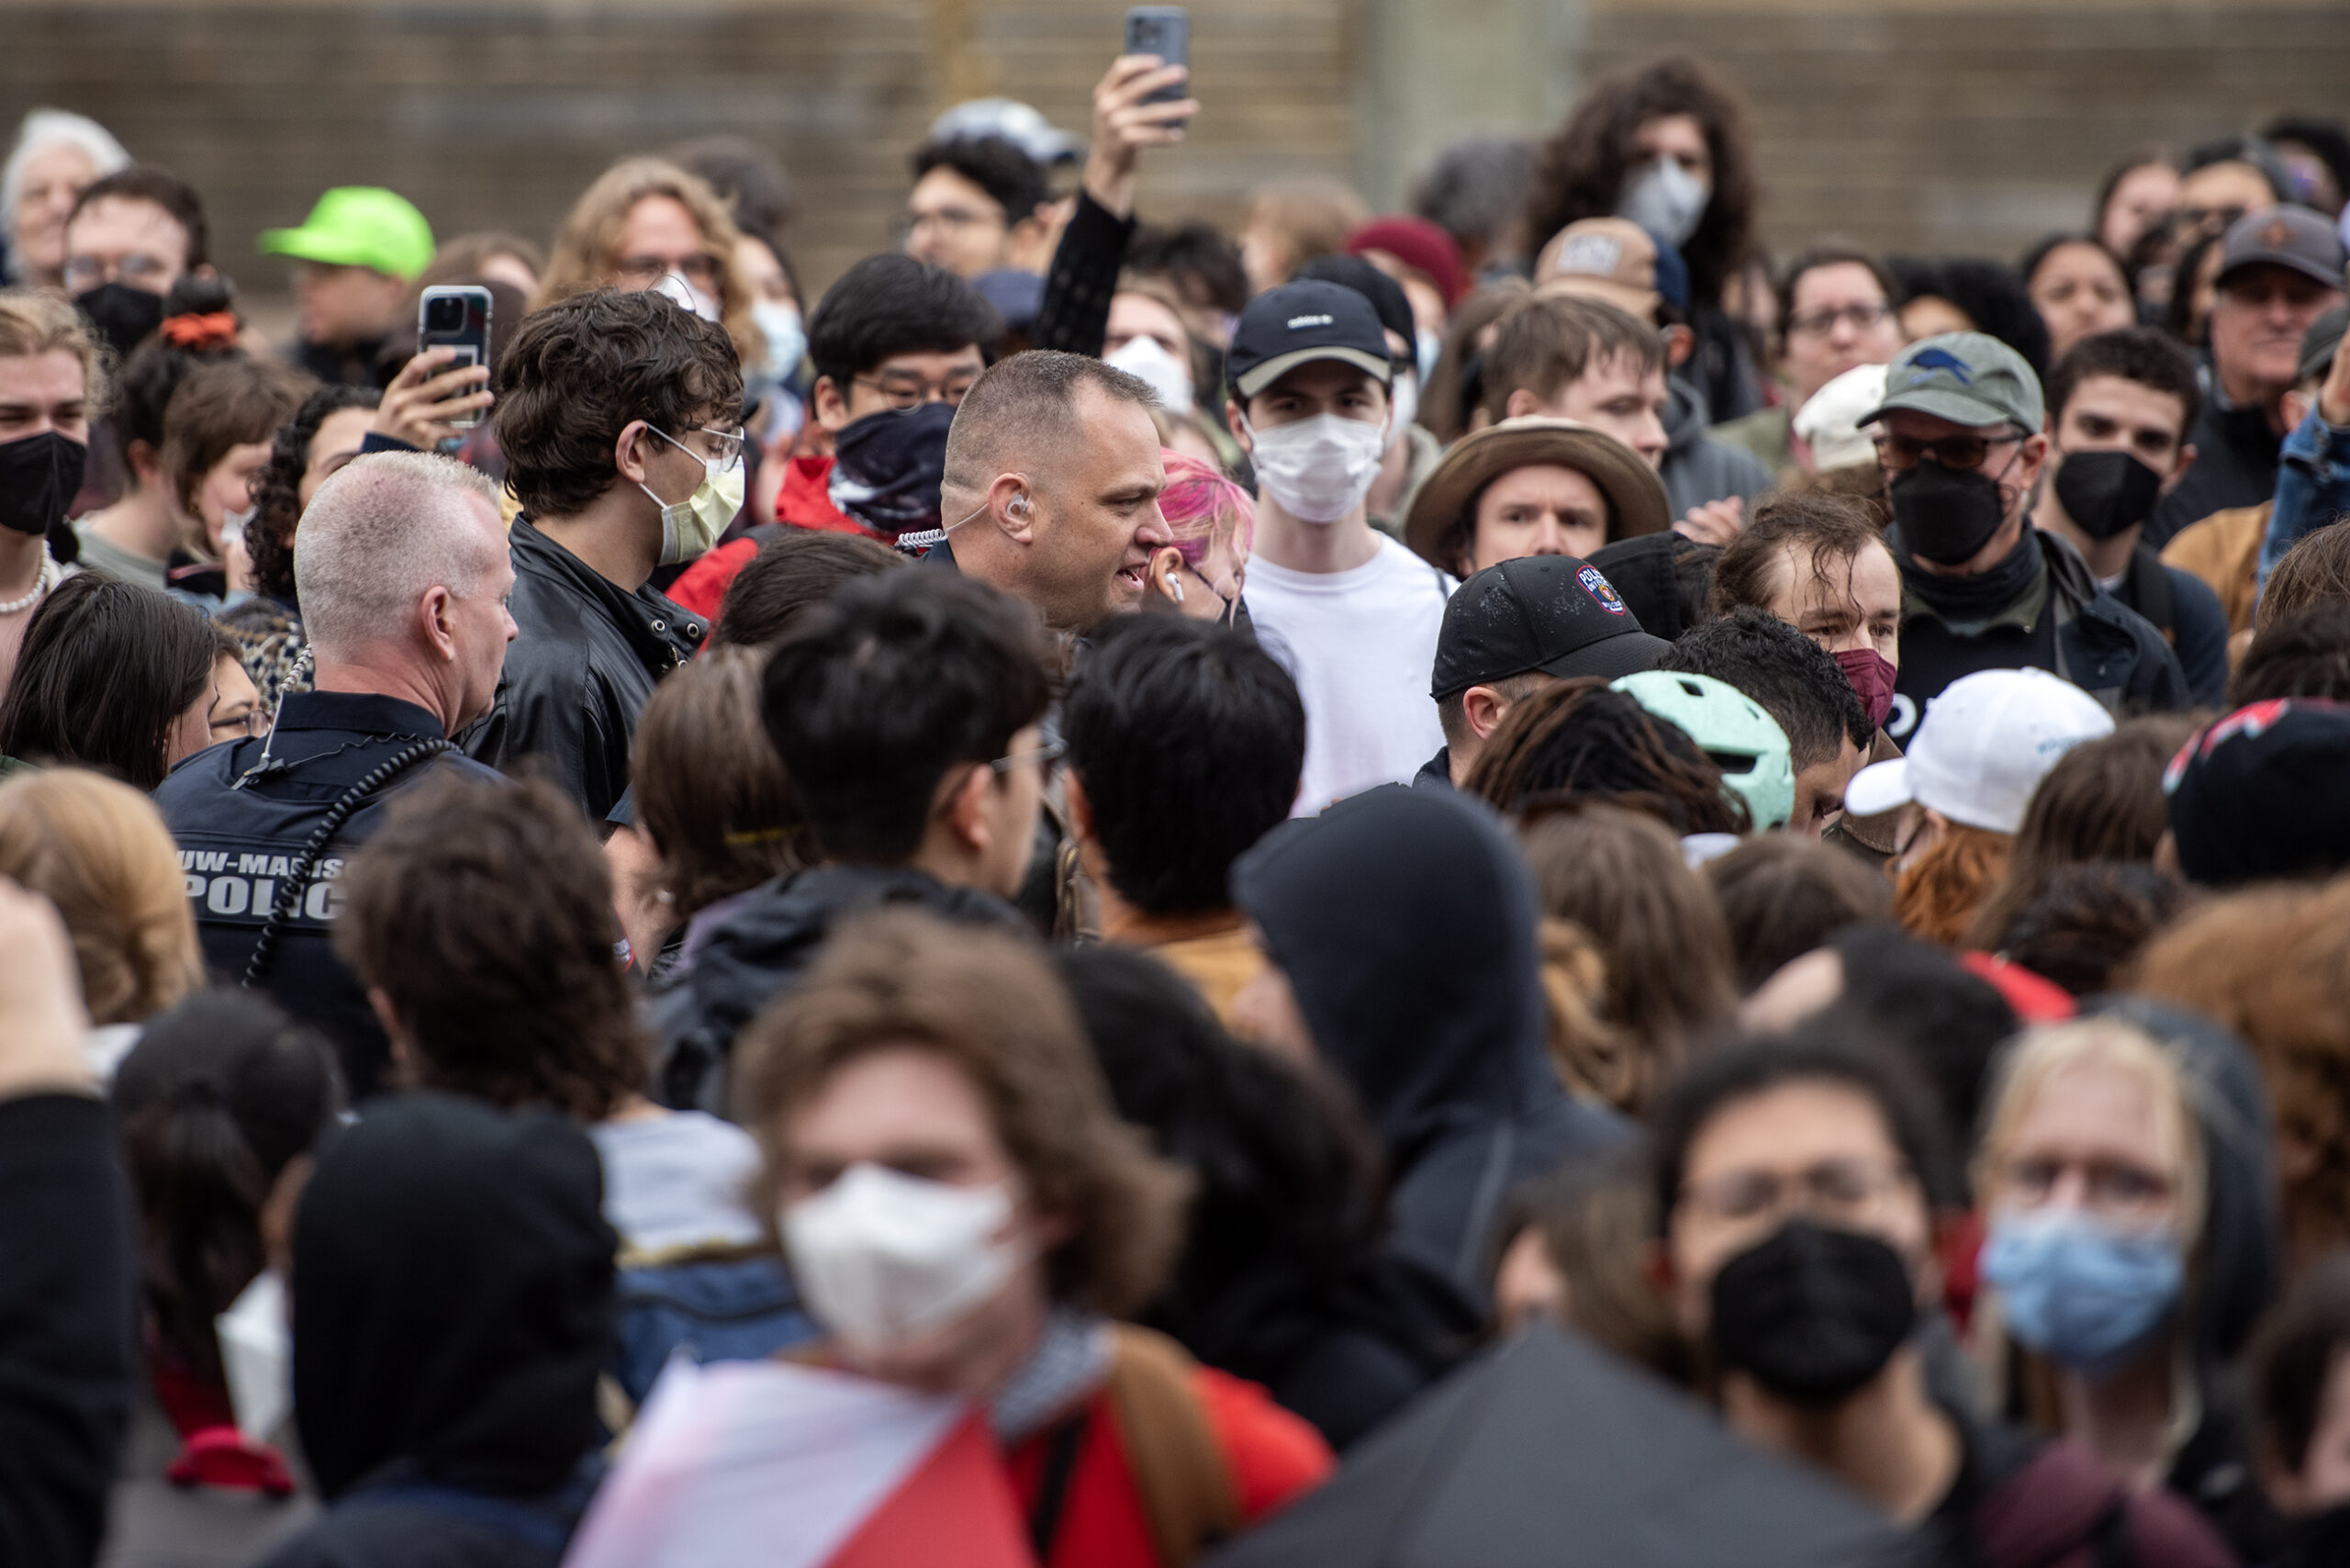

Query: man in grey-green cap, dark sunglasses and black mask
[[1862, 331, 2188, 741]]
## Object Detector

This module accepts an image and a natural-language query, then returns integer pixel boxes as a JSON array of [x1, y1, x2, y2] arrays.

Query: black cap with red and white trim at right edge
[[2162, 699, 2350, 886]]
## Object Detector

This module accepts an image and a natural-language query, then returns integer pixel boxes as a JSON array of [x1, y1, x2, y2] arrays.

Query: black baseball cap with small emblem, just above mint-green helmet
[[1428, 554, 1673, 700]]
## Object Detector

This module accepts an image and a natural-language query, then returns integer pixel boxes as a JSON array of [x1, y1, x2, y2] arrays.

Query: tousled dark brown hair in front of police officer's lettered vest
[[334, 768, 651, 1121]]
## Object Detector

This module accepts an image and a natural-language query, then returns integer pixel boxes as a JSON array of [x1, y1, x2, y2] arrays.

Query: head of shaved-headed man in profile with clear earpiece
[[921, 351, 1175, 633]]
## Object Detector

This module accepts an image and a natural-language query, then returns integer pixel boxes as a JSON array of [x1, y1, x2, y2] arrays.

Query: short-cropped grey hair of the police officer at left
[[294, 452, 505, 658]]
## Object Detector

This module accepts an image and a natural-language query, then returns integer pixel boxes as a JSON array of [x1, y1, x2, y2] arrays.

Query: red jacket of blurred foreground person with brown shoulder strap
[[1006, 1366, 1335, 1568]]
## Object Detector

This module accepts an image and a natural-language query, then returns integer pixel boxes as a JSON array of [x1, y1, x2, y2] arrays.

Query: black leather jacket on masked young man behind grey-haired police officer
[[458, 517, 708, 823]]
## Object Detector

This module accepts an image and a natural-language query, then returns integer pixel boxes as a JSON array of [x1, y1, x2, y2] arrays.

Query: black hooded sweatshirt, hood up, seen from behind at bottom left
[[265, 1093, 616, 1568]]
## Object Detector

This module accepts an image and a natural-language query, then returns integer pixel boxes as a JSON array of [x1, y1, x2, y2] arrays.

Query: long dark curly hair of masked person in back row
[[1525, 54, 1755, 306]]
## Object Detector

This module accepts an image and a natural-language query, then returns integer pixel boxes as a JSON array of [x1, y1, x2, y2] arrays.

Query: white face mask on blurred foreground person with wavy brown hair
[[782, 1161, 1023, 1350]]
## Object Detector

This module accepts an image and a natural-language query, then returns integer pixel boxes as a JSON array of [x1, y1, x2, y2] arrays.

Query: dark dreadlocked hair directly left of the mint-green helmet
[[1461, 675, 1749, 834]]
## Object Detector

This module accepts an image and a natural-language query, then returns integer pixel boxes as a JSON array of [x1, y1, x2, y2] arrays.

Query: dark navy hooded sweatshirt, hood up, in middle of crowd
[[1231, 785, 1628, 1309]]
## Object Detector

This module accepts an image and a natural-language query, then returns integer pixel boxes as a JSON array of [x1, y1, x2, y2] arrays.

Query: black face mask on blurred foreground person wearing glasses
[[1713, 1220, 1918, 1404]]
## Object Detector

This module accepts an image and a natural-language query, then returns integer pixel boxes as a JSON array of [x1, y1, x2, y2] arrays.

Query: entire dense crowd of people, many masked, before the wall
[[0, 42, 2350, 1568]]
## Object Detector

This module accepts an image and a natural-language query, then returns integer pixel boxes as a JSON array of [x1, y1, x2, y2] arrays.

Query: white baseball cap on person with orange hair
[[1845, 670, 2112, 832]]
